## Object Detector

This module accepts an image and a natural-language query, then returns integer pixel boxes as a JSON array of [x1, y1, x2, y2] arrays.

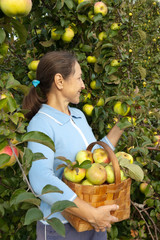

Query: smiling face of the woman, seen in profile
[[63, 62, 85, 104]]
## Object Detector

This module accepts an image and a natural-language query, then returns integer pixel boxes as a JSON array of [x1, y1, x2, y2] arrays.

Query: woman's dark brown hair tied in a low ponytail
[[23, 51, 77, 119]]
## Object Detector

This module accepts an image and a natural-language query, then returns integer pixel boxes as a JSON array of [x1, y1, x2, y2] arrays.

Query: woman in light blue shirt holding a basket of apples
[[23, 51, 123, 240]]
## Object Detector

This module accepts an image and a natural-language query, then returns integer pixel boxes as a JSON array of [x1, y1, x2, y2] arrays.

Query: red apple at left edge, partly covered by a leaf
[[0, 146, 19, 169]]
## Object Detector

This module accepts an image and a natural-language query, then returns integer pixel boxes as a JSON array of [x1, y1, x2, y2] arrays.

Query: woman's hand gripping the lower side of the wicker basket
[[89, 204, 119, 232]]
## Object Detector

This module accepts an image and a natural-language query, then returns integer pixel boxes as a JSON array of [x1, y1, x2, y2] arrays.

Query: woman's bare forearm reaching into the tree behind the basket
[[107, 123, 124, 147]]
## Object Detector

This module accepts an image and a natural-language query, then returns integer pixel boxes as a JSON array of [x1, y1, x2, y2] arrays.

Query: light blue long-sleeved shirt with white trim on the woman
[[27, 104, 114, 223]]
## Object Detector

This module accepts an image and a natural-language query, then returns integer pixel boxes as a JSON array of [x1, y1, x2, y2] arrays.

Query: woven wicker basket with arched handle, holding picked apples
[[63, 141, 131, 232]]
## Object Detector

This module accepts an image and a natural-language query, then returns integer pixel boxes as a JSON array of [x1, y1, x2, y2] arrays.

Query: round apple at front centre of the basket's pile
[[86, 163, 107, 185]]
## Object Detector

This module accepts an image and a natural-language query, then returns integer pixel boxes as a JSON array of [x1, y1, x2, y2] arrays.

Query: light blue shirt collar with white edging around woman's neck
[[38, 104, 82, 125]]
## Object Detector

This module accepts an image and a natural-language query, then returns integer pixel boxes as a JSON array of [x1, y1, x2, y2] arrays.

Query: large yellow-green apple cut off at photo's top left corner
[[1, 0, 32, 17]]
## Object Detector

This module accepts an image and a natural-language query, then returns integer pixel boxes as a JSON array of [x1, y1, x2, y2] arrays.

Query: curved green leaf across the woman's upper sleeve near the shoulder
[[21, 131, 55, 152]]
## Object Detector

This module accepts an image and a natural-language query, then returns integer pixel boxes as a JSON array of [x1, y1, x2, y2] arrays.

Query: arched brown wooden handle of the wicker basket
[[87, 141, 121, 184]]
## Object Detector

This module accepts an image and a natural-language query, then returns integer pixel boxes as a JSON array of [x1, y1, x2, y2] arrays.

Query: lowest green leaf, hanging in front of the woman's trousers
[[47, 218, 65, 237]]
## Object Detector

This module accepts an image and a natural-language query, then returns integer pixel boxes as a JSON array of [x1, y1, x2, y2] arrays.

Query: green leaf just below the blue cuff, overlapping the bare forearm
[[51, 200, 77, 213]]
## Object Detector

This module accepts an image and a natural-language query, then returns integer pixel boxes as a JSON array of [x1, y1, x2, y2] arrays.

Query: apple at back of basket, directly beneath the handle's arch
[[93, 148, 110, 163]]
